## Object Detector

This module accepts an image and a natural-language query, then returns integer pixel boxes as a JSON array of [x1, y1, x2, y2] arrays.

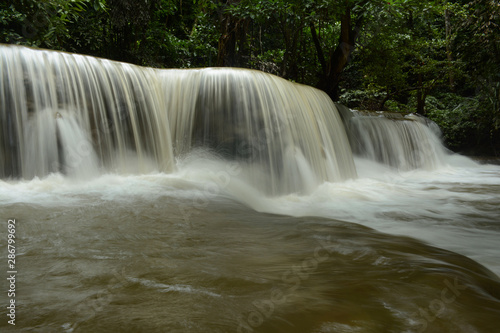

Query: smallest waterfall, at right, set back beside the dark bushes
[[337, 105, 447, 171]]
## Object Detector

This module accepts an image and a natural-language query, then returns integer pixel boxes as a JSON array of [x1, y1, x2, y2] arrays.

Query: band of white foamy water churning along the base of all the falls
[[0, 151, 500, 275]]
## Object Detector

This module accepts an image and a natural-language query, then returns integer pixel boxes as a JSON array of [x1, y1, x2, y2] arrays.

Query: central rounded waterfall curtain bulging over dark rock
[[160, 69, 356, 194]]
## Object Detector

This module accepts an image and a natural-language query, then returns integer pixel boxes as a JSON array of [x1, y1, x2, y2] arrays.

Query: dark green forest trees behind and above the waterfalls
[[0, 0, 500, 156]]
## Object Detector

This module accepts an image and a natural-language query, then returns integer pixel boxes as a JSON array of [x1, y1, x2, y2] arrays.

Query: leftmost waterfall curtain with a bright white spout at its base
[[0, 46, 173, 179]]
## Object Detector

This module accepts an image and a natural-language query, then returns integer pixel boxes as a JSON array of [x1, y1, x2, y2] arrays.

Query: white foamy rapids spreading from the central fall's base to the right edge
[[241, 159, 500, 275]]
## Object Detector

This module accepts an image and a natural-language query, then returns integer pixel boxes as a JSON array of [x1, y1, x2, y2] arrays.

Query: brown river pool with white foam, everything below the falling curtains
[[0, 156, 500, 332]]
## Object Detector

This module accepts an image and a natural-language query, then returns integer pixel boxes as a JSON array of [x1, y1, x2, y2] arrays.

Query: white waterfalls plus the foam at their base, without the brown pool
[[0, 46, 500, 273]]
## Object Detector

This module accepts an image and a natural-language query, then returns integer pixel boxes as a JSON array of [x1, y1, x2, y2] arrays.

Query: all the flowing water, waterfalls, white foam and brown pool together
[[0, 46, 500, 332]]
